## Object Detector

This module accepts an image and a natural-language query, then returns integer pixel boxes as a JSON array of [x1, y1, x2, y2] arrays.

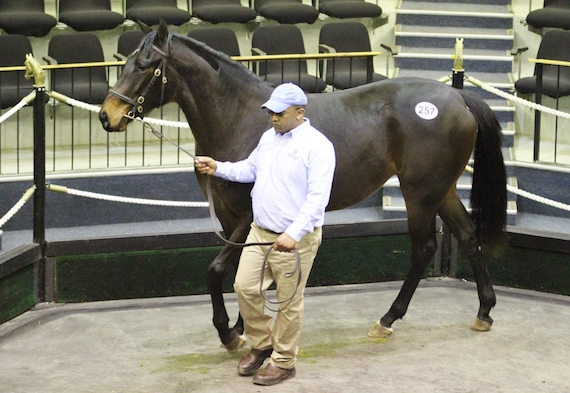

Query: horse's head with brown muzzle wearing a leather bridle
[[99, 20, 174, 132]]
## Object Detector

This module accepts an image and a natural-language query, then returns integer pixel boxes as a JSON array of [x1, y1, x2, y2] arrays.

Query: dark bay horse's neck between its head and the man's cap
[[172, 39, 272, 160]]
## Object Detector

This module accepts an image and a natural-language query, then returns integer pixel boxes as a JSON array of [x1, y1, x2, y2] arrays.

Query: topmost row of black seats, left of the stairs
[[0, 0, 382, 37]]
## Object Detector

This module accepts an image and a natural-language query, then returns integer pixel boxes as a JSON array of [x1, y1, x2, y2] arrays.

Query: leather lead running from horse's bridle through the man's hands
[[135, 115, 301, 312]]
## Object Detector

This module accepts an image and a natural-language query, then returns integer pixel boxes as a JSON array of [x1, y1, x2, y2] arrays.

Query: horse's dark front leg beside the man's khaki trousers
[[206, 219, 251, 353]]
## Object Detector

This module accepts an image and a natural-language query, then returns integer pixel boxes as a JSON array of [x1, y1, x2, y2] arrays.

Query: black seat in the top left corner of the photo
[[0, 0, 57, 37]]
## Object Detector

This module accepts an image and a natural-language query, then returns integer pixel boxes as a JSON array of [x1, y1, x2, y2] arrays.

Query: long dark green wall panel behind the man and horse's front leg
[[56, 234, 410, 302]]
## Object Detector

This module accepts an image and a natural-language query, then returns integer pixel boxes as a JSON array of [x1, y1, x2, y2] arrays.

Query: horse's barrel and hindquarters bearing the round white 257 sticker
[[307, 78, 477, 210]]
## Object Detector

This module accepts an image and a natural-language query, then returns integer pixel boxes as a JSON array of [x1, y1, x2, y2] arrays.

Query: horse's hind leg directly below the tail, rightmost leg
[[438, 192, 497, 331]]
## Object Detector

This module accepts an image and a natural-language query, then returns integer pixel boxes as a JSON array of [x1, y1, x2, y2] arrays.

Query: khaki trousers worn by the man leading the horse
[[234, 224, 322, 369]]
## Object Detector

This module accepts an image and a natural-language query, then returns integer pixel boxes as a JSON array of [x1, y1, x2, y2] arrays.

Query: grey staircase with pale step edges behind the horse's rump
[[383, 0, 517, 225]]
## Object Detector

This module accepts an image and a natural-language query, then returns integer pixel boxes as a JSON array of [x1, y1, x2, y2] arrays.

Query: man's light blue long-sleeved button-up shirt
[[214, 118, 336, 241]]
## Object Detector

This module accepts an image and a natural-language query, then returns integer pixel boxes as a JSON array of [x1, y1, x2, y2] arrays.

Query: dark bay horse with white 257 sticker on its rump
[[99, 23, 507, 352]]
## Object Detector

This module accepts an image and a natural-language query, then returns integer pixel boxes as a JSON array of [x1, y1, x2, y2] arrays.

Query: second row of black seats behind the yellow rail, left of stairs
[[0, 22, 386, 108]]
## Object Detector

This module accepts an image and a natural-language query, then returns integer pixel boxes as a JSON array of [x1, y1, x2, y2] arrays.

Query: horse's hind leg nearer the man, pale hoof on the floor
[[368, 208, 437, 338]]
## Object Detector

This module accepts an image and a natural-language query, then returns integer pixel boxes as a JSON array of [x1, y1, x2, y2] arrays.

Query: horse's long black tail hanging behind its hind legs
[[460, 90, 507, 252]]
